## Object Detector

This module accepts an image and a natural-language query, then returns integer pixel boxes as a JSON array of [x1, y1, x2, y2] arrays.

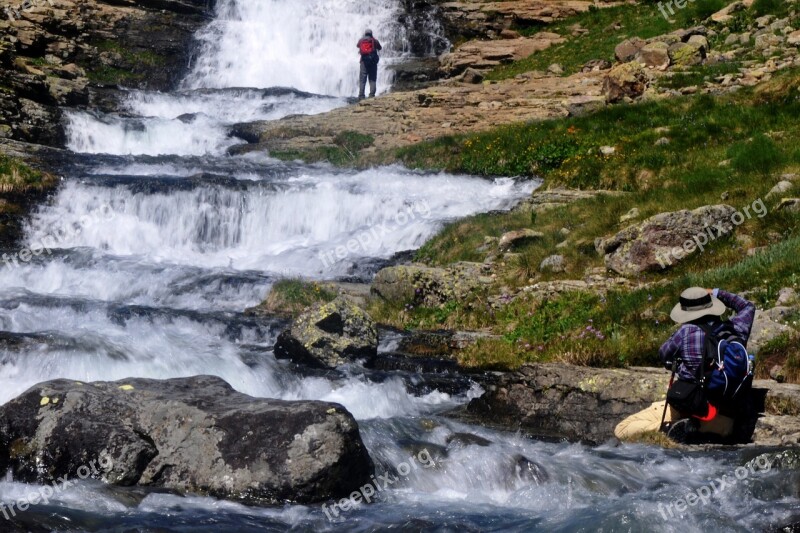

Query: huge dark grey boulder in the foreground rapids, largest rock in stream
[[0, 376, 372, 503]]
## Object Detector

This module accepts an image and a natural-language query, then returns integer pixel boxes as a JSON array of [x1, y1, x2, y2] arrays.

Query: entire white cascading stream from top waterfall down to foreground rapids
[[0, 0, 798, 533]]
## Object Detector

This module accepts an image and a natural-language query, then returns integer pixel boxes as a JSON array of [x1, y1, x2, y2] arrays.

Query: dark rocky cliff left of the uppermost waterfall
[[0, 0, 214, 146]]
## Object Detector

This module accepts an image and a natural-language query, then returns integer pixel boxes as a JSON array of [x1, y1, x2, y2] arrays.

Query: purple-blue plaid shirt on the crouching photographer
[[658, 289, 756, 381]]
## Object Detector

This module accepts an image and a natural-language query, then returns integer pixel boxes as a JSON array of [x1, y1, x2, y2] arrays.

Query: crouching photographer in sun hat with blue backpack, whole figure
[[614, 287, 756, 442]]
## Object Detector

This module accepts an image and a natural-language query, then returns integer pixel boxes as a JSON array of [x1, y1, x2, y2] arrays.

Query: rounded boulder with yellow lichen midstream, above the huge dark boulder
[[275, 296, 378, 368]]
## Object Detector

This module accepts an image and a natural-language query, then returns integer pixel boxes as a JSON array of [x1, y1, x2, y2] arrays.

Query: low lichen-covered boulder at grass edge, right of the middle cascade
[[372, 262, 492, 307]]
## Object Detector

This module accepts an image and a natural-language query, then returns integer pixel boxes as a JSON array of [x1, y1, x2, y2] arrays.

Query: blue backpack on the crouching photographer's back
[[697, 322, 755, 406]]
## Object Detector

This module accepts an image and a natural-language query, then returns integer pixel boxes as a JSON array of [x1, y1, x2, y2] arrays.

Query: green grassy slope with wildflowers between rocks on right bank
[[371, 2, 800, 378]]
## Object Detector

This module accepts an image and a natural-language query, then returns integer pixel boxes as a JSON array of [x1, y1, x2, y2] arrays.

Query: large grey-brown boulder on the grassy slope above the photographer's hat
[[595, 204, 737, 276]]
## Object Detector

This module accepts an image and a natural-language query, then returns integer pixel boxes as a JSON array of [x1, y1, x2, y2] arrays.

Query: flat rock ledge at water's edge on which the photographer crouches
[[467, 363, 800, 446]]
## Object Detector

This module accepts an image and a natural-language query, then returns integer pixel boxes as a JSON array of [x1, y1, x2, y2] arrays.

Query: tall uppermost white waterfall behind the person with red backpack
[[185, 0, 403, 96]]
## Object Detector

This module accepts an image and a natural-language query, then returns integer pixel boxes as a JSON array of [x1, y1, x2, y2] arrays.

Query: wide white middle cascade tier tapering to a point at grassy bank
[[21, 168, 535, 276]]
